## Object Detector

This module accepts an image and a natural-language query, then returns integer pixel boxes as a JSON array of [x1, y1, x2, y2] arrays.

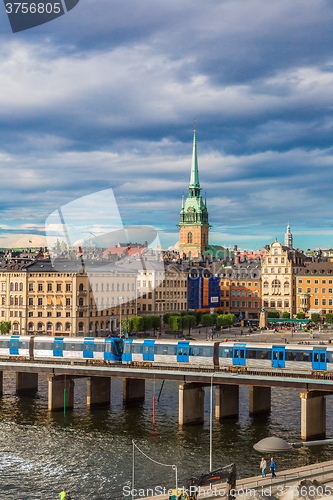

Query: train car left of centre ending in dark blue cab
[[33, 337, 123, 361]]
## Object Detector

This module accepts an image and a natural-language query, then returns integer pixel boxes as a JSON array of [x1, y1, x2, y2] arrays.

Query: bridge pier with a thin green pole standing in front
[[47, 375, 74, 411]]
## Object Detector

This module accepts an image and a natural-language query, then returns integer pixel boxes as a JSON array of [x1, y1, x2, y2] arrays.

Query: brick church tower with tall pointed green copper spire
[[179, 130, 210, 258]]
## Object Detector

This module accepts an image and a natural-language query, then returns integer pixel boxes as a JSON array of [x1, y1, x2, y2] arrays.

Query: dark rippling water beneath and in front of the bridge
[[0, 374, 333, 500]]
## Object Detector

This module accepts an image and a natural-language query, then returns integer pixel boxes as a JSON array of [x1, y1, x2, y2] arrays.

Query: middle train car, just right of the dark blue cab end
[[122, 339, 218, 368]]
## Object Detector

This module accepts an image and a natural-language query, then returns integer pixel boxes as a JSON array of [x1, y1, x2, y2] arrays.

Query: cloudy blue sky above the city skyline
[[0, 0, 333, 250]]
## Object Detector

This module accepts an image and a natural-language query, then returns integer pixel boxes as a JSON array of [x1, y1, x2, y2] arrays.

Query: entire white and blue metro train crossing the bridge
[[0, 335, 333, 373]]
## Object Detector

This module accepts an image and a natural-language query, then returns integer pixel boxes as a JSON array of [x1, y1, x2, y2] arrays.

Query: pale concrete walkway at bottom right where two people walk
[[135, 459, 333, 500]]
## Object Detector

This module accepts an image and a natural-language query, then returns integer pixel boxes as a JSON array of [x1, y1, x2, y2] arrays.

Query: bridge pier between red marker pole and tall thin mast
[[178, 383, 205, 425]]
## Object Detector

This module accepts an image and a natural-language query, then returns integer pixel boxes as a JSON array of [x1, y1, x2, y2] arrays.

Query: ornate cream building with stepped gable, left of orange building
[[261, 238, 310, 318]]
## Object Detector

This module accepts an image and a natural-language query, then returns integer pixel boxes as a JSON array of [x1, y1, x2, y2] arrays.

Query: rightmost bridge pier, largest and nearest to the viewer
[[300, 391, 326, 440]]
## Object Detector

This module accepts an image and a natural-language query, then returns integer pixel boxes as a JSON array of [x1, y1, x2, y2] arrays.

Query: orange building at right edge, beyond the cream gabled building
[[296, 259, 333, 318]]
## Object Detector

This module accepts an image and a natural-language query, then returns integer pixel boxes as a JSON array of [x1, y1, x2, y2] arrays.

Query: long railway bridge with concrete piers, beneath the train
[[0, 359, 333, 440]]
